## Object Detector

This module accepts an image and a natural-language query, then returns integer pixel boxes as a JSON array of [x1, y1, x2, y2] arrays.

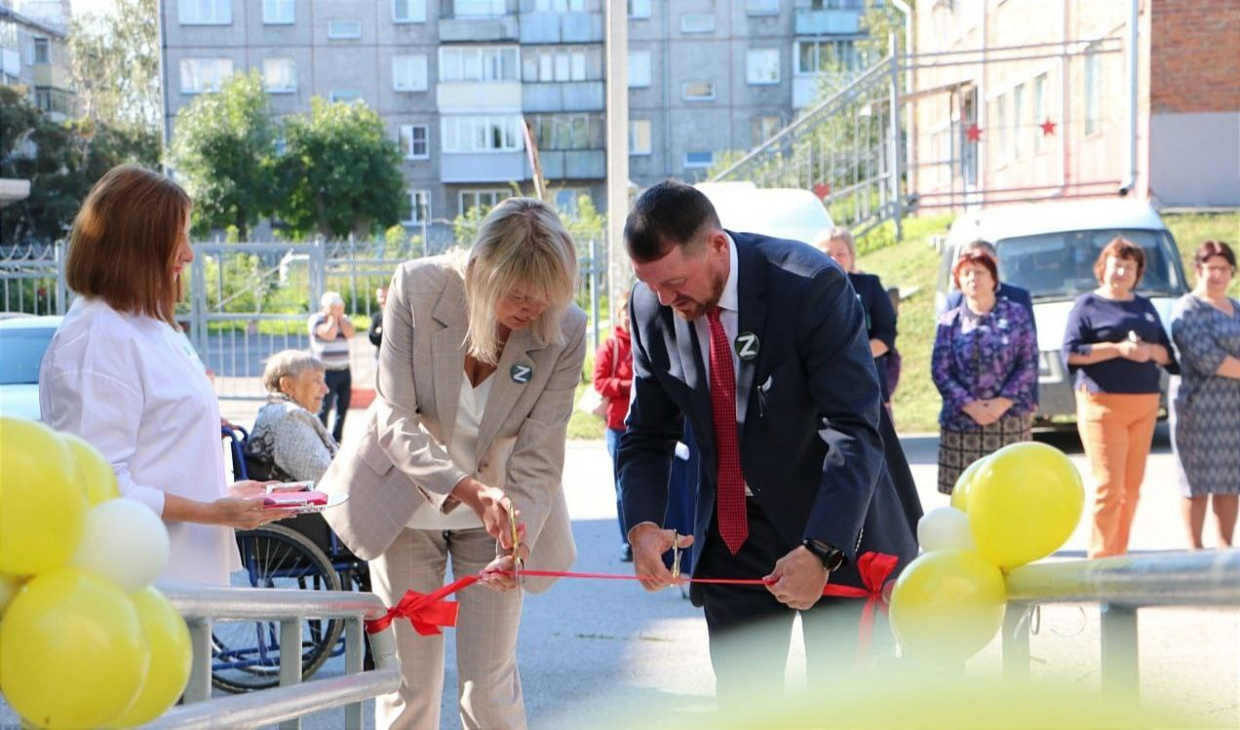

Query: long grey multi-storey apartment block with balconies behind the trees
[[160, 0, 864, 233]]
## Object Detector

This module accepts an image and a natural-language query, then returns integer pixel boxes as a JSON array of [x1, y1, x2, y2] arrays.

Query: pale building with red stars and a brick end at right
[[910, 0, 1240, 206]]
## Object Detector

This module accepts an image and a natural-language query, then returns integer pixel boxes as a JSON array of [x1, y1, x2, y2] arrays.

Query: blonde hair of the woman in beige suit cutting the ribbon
[[464, 198, 577, 364]]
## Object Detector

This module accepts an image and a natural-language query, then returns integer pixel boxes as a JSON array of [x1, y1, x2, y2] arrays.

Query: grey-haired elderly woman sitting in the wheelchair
[[246, 350, 339, 482]]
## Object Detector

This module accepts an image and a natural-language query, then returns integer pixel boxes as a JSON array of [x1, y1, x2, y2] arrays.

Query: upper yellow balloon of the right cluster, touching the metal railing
[[968, 441, 1085, 570]]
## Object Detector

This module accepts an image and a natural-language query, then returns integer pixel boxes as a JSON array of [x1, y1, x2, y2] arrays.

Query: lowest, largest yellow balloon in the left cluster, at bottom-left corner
[[0, 568, 150, 728]]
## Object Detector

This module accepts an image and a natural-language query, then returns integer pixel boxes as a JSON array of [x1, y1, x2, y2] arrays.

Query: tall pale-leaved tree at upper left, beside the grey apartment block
[[68, 0, 161, 167]]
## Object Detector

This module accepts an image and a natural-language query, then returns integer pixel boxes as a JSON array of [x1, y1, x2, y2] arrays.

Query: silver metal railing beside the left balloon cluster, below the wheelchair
[[148, 585, 401, 730]]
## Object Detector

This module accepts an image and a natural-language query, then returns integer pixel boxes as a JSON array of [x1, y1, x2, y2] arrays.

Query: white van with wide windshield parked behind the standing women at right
[[935, 200, 1187, 425]]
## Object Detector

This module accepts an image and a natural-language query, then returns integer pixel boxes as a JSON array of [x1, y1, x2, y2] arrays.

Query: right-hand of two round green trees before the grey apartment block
[[277, 97, 408, 238]]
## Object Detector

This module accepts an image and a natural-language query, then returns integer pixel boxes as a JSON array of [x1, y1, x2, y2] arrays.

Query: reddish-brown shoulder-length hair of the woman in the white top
[[64, 165, 192, 325]]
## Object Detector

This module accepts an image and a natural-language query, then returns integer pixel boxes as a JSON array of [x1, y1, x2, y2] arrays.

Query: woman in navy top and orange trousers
[[1064, 237, 1178, 558]]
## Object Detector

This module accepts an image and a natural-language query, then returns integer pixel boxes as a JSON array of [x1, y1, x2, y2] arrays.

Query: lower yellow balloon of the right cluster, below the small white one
[[890, 549, 1007, 663]]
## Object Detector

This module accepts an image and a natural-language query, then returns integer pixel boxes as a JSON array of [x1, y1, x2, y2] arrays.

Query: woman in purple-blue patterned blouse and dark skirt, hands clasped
[[931, 252, 1038, 495]]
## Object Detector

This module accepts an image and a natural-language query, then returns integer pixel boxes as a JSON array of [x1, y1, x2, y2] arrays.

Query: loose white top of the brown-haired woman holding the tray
[[38, 297, 241, 585]]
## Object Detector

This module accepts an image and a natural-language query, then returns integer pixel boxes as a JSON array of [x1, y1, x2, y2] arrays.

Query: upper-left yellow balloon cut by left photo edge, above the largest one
[[0, 418, 87, 575]]
